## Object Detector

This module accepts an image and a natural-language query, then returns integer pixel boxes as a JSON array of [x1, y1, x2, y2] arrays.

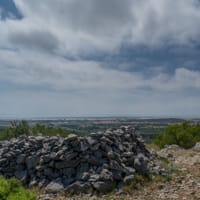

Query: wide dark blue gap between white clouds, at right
[[97, 45, 200, 76]]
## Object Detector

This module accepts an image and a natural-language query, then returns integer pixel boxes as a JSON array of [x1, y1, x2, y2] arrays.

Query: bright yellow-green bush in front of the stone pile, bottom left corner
[[0, 177, 36, 200]]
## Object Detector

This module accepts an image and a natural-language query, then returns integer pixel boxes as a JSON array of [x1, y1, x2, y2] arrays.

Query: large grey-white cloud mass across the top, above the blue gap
[[0, 0, 200, 55]]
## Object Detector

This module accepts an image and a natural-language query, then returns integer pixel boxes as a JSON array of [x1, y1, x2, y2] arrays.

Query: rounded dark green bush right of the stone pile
[[154, 121, 200, 149]]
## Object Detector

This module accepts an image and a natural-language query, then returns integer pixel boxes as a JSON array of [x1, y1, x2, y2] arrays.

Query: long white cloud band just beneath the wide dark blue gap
[[0, 50, 200, 91]]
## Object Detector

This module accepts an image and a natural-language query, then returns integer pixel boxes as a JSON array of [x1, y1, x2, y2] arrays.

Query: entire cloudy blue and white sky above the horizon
[[0, 0, 200, 118]]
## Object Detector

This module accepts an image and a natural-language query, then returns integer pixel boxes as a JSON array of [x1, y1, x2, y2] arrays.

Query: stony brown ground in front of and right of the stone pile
[[39, 145, 200, 200]]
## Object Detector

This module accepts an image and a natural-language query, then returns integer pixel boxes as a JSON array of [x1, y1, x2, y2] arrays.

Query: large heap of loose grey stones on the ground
[[0, 126, 157, 193]]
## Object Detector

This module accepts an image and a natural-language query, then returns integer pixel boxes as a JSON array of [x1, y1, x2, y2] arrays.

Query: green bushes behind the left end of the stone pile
[[0, 120, 69, 140]]
